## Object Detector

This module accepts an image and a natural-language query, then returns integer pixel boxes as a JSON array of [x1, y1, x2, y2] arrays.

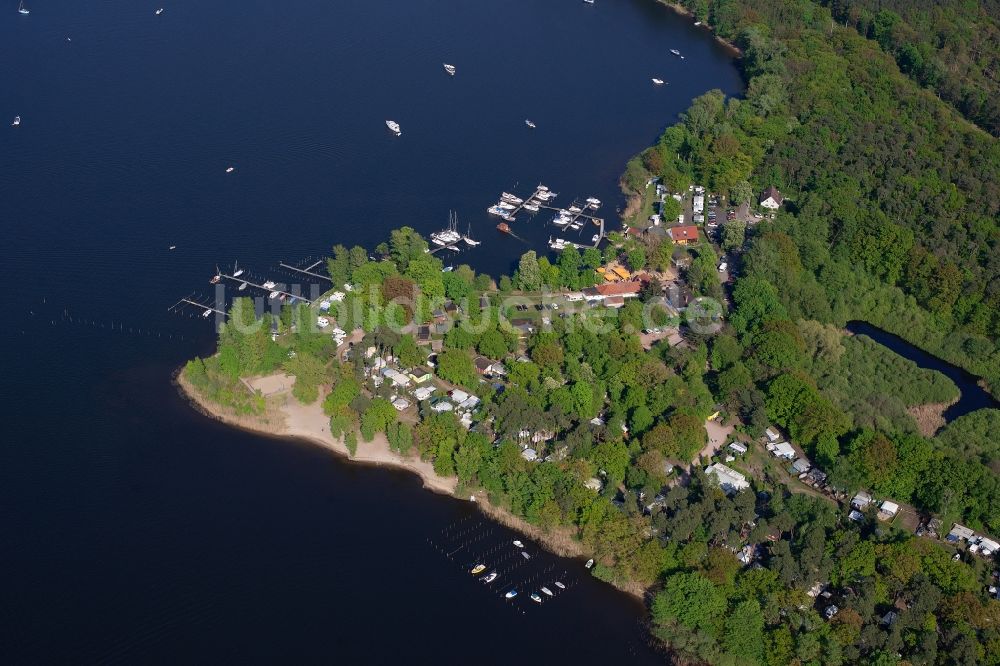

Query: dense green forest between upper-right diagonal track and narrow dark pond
[[624, 0, 1000, 386]]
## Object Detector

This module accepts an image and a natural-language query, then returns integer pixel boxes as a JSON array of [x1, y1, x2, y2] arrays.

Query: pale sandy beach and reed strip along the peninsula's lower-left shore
[[173, 368, 647, 604]]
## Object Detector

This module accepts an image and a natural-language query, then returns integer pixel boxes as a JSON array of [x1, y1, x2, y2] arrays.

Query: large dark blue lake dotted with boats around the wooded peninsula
[[0, 0, 741, 663]]
